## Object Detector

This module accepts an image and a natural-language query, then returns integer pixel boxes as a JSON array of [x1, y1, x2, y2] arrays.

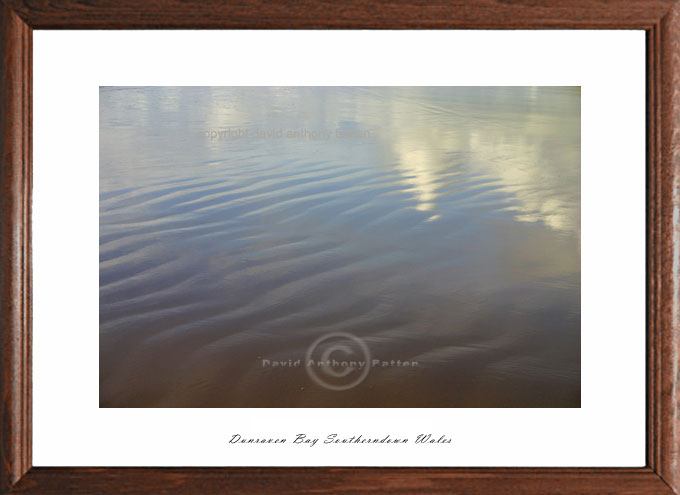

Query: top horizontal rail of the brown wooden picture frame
[[0, 0, 671, 29]]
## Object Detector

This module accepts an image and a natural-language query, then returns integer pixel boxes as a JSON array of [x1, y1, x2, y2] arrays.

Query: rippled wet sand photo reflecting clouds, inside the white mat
[[99, 87, 580, 407]]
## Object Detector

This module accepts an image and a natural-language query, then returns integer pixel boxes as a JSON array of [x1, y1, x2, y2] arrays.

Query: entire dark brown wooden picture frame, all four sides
[[0, 0, 680, 495]]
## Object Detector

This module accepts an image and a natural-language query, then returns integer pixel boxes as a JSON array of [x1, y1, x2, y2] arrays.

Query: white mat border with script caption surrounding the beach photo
[[33, 31, 645, 466]]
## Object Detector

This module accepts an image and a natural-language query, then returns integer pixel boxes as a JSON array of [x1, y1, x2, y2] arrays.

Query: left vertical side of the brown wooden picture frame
[[0, 2, 32, 492]]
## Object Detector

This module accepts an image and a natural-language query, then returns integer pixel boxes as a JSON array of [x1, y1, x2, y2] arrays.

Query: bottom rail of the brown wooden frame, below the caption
[[7, 468, 671, 495]]
